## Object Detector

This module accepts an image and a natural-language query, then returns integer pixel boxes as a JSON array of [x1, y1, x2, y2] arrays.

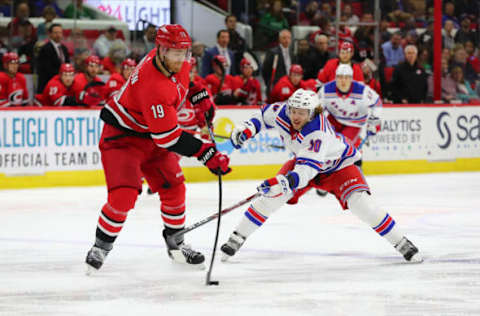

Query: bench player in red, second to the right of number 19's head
[[233, 58, 262, 105]]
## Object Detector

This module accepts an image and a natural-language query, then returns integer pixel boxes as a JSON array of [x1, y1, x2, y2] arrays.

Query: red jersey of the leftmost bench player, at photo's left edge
[[0, 72, 28, 107]]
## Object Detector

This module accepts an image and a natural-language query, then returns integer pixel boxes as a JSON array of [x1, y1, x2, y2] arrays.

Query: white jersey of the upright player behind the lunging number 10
[[318, 81, 382, 127]]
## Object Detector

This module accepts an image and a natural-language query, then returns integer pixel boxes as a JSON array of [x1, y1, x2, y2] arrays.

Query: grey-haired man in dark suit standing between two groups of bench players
[[262, 29, 293, 94]]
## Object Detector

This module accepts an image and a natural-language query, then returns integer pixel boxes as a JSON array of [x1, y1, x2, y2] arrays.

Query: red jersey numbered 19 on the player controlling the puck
[[104, 49, 190, 148]]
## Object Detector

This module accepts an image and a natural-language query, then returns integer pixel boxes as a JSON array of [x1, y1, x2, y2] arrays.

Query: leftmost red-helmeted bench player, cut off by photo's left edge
[[0, 52, 28, 107]]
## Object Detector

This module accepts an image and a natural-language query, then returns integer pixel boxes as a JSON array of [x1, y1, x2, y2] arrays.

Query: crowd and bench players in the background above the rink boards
[[0, 0, 480, 106]]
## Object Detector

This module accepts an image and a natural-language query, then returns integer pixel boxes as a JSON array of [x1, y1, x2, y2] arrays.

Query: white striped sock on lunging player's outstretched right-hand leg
[[348, 191, 403, 247]]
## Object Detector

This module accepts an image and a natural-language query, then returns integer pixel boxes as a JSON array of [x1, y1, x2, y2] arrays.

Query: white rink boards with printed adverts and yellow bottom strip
[[0, 105, 480, 188]]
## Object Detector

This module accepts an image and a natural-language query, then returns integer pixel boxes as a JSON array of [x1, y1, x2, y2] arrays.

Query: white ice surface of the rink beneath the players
[[0, 173, 480, 316]]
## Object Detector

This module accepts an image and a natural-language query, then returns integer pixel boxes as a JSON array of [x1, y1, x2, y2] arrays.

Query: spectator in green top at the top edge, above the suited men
[[258, 0, 289, 43]]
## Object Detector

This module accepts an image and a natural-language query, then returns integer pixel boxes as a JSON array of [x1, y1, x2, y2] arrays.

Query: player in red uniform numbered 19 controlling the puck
[[86, 24, 230, 271]]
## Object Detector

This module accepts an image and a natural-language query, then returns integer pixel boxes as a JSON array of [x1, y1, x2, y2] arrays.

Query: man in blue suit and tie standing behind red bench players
[[201, 30, 235, 77]]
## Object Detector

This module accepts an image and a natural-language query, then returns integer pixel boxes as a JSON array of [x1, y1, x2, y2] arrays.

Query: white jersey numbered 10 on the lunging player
[[249, 103, 361, 188]]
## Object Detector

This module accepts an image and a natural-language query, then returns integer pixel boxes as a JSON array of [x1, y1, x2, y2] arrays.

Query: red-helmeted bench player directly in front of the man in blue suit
[[204, 55, 235, 105]]
